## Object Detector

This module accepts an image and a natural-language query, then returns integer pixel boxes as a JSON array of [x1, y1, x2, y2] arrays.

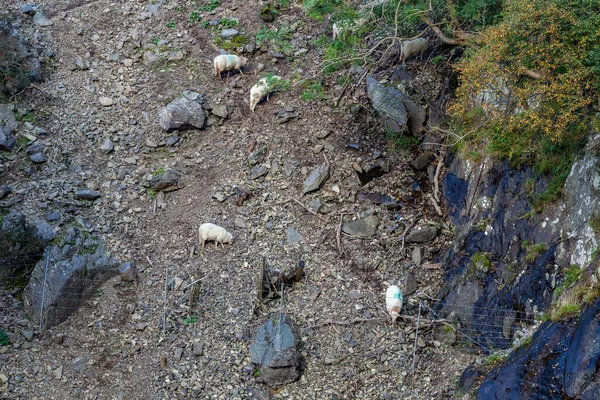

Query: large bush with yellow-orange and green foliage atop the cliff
[[450, 0, 600, 171]]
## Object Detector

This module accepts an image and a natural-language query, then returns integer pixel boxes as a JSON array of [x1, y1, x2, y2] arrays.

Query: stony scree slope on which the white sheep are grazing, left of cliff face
[[0, 0, 472, 399]]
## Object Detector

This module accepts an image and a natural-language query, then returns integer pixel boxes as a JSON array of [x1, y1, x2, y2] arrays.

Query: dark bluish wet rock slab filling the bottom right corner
[[477, 300, 600, 400]]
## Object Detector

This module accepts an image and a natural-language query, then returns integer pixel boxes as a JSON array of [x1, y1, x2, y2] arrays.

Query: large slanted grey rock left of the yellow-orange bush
[[366, 76, 408, 133]]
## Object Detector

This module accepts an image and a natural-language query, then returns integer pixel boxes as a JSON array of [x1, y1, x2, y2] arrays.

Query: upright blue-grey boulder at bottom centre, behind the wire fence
[[250, 314, 304, 387]]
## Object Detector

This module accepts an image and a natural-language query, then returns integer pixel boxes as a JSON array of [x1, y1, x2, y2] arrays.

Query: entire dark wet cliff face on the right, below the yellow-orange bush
[[435, 137, 600, 399]]
